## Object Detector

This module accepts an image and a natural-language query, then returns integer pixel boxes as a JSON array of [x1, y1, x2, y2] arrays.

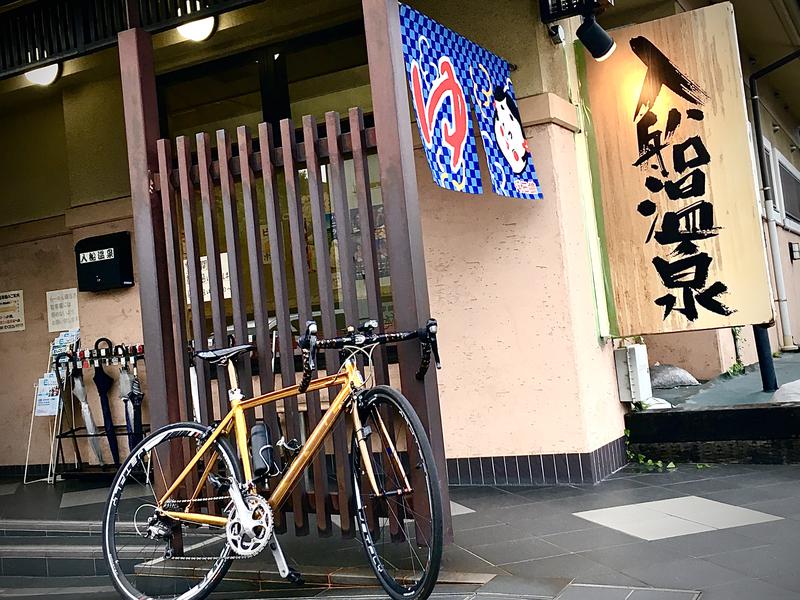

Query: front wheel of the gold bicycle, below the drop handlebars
[[351, 386, 442, 600]]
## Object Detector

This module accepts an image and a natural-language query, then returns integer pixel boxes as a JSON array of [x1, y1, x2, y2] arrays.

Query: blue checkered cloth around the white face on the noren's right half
[[462, 41, 542, 200]]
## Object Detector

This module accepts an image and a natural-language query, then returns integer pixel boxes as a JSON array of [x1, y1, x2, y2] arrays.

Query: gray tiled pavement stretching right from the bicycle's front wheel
[[0, 465, 800, 600]]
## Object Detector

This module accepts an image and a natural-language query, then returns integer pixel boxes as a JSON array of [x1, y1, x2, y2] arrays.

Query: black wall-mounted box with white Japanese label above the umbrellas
[[75, 231, 133, 292]]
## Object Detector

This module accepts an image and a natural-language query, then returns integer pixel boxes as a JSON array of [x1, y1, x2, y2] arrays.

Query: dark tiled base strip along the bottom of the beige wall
[[447, 437, 628, 485]]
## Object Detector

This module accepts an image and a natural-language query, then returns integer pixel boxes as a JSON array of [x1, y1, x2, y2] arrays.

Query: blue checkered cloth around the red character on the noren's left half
[[400, 4, 483, 194]]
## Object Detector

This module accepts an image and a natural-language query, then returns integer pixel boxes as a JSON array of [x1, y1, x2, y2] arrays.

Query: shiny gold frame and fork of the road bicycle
[[158, 360, 400, 527]]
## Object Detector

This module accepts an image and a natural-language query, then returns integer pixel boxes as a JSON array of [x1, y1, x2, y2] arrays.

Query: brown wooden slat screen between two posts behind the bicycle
[[155, 109, 388, 536]]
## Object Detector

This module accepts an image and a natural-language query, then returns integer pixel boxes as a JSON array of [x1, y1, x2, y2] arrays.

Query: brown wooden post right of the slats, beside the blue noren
[[361, 0, 453, 541]]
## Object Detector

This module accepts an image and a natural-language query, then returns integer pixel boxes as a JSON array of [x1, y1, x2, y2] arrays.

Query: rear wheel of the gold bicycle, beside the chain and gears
[[103, 423, 243, 600]]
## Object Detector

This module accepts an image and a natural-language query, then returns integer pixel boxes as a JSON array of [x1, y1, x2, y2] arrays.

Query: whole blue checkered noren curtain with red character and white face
[[400, 4, 542, 199]]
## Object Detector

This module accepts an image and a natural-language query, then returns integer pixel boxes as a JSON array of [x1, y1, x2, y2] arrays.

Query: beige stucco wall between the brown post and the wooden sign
[[413, 1, 623, 457]]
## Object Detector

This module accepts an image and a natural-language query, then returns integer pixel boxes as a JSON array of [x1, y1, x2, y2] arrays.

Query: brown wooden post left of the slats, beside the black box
[[118, 28, 180, 436]]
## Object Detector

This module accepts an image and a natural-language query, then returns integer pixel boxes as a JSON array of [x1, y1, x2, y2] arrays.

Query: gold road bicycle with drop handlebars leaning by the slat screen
[[103, 319, 442, 600]]
